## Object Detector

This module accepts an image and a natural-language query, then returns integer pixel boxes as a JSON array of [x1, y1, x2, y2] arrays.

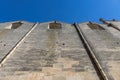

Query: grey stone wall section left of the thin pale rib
[[0, 22, 33, 61]]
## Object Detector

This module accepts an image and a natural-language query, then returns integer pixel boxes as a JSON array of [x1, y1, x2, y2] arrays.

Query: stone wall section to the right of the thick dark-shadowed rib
[[79, 24, 120, 80]]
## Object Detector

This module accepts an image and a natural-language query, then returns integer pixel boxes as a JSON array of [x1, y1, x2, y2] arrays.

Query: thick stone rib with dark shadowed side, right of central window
[[73, 24, 109, 80]]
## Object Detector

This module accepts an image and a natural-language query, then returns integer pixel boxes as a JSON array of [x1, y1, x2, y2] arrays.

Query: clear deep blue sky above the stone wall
[[0, 0, 120, 23]]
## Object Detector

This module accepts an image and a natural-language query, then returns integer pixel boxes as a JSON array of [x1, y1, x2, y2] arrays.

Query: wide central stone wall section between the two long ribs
[[0, 23, 99, 80]]
